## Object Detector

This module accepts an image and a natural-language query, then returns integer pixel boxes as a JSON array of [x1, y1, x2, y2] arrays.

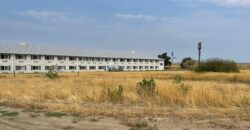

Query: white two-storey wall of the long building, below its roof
[[0, 54, 164, 73]]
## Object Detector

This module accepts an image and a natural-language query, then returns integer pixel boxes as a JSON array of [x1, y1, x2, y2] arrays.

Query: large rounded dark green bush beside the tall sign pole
[[195, 58, 239, 72]]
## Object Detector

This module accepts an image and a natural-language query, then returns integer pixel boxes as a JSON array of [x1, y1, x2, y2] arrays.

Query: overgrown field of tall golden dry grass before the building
[[0, 70, 250, 121]]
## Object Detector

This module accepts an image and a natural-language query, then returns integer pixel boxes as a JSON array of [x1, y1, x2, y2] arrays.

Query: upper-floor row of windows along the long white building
[[0, 54, 159, 62]]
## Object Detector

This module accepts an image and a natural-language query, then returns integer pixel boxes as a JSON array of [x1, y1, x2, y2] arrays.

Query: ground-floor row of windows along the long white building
[[0, 66, 159, 71]]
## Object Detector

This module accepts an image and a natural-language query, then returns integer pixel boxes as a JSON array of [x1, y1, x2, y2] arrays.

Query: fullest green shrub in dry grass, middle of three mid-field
[[136, 79, 158, 96]]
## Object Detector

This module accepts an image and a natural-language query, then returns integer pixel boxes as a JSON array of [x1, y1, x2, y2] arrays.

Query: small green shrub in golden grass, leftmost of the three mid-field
[[108, 85, 123, 102]]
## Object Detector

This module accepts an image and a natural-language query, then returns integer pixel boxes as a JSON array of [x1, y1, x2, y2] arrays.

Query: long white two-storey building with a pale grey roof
[[0, 44, 164, 73]]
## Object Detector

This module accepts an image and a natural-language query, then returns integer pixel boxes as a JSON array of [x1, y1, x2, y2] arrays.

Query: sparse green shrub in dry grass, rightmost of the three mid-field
[[173, 75, 192, 96]]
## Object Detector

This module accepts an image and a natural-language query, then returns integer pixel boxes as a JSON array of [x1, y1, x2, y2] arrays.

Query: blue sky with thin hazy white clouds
[[0, 0, 250, 62]]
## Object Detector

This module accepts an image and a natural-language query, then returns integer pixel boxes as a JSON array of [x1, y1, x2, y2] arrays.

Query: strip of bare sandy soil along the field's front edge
[[0, 106, 250, 130]]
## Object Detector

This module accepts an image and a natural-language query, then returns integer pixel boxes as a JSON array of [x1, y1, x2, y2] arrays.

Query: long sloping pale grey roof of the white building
[[0, 43, 164, 60]]
